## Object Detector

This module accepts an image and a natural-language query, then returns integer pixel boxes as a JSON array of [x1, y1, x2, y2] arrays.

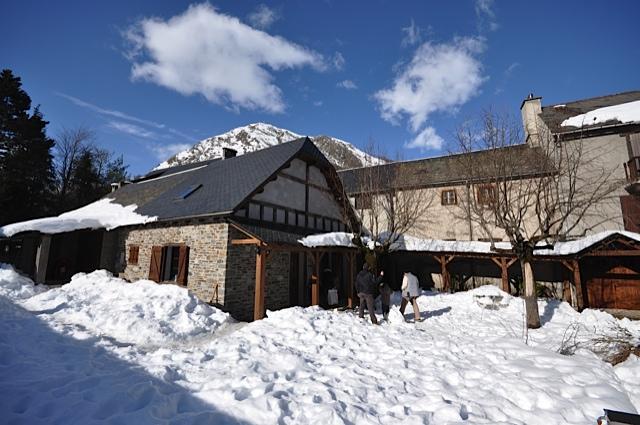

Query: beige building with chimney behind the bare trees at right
[[339, 91, 640, 241]]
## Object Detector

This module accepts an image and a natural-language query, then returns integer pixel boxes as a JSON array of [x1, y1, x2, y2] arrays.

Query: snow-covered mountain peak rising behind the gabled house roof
[[156, 122, 385, 169]]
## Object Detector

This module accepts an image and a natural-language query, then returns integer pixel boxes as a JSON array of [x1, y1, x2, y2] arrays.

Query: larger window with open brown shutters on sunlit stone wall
[[149, 245, 189, 286]]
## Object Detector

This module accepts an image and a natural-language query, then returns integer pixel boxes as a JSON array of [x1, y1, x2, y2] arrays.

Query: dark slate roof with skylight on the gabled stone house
[[107, 138, 330, 220]]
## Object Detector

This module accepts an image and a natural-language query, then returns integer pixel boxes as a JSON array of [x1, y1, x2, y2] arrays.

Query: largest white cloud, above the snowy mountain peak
[[125, 3, 325, 112]]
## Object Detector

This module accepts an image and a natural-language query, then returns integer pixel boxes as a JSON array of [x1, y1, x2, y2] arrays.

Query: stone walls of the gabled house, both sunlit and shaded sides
[[118, 222, 290, 320]]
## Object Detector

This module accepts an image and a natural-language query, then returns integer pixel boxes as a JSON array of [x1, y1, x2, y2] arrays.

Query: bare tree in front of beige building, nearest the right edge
[[457, 112, 621, 328]]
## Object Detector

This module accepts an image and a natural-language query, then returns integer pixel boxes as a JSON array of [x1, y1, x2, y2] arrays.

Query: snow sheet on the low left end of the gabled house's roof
[[0, 198, 157, 237]]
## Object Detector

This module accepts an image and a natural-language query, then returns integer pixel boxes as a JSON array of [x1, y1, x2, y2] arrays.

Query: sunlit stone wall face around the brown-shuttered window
[[120, 222, 229, 303]]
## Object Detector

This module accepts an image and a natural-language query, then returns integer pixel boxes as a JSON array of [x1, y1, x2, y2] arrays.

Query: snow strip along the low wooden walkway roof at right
[[299, 231, 640, 255]]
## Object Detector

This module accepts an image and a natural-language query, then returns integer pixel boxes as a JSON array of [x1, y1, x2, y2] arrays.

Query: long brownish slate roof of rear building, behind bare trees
[[338, 144, 549, 194]]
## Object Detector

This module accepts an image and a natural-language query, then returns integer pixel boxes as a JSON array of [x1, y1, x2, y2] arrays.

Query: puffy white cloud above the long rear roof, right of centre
[[374, 37, 486, 133]]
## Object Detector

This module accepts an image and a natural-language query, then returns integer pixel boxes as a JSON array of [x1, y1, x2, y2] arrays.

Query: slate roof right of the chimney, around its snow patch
[[540, 91, 640, 133]]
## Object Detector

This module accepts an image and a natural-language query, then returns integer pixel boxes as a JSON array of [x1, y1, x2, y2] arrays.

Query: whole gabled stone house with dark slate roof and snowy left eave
[[0, 138, 355, 320]]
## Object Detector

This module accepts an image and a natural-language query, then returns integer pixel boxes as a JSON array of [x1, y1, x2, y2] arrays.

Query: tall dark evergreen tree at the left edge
[[0, 69, 54, 225]]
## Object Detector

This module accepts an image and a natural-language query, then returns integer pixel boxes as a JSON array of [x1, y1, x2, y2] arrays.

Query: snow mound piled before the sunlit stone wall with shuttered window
[[22, 270, 229, 345]]
